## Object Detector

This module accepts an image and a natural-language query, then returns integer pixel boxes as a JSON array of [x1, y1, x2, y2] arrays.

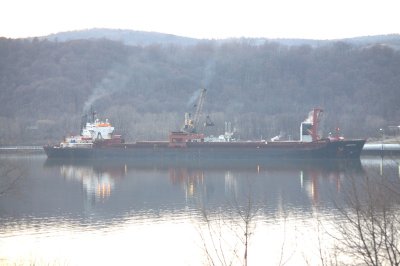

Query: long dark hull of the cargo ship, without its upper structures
[[44, 139, 365, 160]]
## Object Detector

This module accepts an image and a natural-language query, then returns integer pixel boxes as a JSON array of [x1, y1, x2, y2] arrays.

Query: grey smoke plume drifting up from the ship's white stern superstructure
[[83, 65, 129, 113]]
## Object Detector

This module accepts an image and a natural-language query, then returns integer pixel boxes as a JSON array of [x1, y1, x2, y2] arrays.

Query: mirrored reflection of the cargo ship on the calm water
[[45, 159, 362, 207]]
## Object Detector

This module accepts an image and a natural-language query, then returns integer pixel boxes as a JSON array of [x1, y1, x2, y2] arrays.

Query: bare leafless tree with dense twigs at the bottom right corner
[[337, 167, 400, 265]]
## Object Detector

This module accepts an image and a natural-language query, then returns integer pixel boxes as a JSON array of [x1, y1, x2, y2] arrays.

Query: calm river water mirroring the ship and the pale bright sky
[[0, 155, 400, 265]]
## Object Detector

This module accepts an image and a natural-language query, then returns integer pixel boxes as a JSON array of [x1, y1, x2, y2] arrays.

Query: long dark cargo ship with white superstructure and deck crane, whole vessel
[[43, 106, 365, 161]]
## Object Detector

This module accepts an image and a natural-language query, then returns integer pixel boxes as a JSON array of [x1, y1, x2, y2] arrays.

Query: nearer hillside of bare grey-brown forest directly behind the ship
[[0, 38, 400, 145]]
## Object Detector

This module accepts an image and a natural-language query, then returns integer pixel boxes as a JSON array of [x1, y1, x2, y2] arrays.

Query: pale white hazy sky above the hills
[[0, 0, 400, 39]]
